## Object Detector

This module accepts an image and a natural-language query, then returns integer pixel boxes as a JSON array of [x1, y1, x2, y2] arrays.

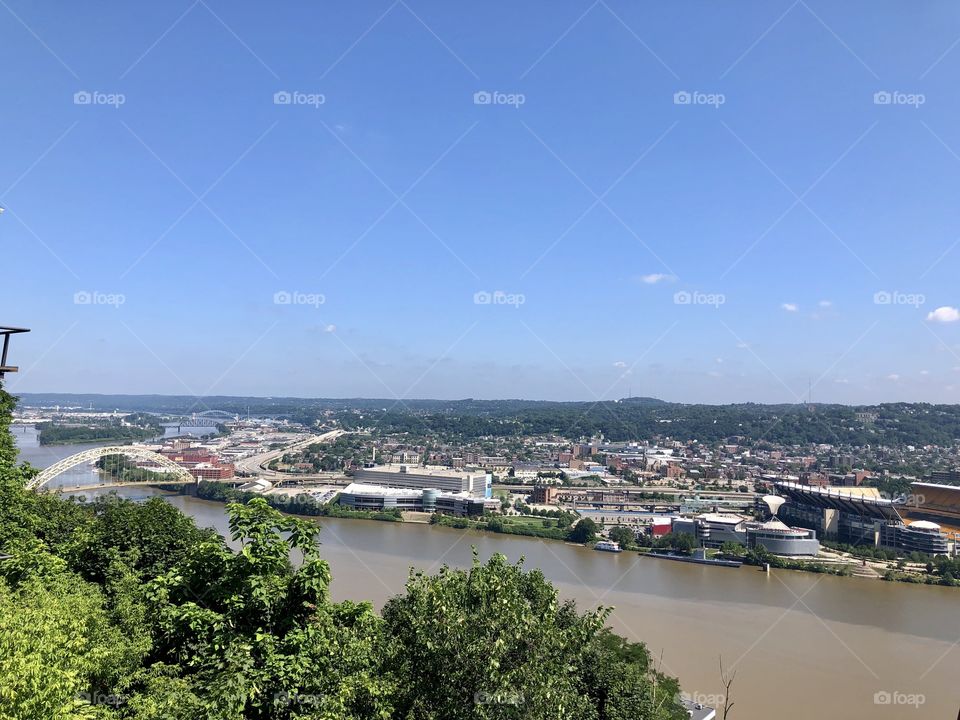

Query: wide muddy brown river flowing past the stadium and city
[[11, 436, 960, 720]]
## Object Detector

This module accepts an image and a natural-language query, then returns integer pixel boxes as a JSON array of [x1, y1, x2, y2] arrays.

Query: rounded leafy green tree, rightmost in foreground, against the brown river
[[383, 554, 682, 720]]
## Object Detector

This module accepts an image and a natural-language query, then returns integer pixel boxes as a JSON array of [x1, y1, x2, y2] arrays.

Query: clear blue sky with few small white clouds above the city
[[0, 0, 960, 403]]
